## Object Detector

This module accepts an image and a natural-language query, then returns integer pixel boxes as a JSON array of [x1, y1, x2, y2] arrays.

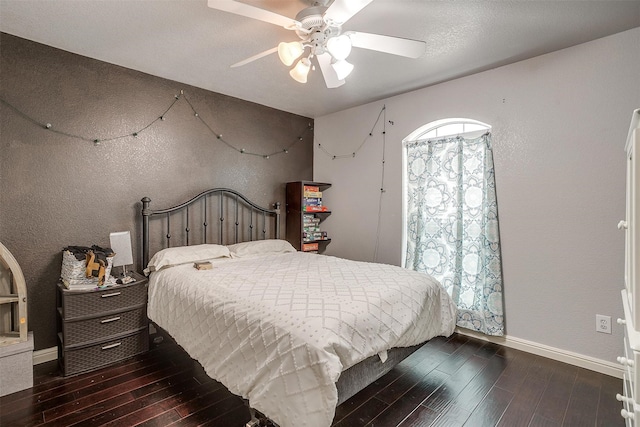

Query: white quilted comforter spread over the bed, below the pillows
[[148, 252, 456, 427]]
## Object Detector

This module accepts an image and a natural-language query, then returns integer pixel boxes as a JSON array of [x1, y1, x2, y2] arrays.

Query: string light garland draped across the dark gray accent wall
[[0, 90, 313, 159]]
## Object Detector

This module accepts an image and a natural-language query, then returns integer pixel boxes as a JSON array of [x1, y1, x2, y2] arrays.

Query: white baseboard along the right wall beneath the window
[[456, 328, 624, 378]]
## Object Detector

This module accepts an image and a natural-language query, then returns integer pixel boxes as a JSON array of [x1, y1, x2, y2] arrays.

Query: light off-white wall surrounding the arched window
[[314, 28, 640, 362]]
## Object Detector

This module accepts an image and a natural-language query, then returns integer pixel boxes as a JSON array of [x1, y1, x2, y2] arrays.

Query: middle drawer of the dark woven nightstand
[[62, 305, 148, 346]]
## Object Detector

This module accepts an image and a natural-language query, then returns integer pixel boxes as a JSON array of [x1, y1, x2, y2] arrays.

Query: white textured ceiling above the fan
[[0, 0, 640, 118]]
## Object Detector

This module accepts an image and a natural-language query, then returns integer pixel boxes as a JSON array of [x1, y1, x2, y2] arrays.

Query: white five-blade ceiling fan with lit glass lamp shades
[[208, 0, 426, 88]]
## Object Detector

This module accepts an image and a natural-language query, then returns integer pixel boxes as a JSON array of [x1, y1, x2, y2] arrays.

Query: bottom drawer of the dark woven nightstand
[[59, 328, 149, 376]]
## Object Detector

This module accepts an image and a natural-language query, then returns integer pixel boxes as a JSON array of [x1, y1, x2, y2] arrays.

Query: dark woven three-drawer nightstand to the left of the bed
[[57, 273, 149, 376]]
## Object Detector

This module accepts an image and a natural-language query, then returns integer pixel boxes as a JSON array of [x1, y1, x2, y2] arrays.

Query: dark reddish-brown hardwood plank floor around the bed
[[0, 334, 624, 427]]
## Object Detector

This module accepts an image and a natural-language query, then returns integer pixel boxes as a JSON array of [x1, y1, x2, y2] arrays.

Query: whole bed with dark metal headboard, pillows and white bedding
[[142, 189, 456, 427]]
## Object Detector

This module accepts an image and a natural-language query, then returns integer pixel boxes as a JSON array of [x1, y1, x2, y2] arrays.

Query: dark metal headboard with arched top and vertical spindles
[[142, 188, 280, 268]]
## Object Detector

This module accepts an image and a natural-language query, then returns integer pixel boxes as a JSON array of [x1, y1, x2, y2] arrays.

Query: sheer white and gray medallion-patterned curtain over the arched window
[[404, 133, 504, 335]]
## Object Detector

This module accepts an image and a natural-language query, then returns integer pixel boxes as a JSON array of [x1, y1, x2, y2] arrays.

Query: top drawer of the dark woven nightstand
[[62, 281, 147, 320]]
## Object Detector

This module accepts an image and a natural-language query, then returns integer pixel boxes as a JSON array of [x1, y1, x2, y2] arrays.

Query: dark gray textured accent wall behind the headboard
[[0, 33, 313, 350]]
